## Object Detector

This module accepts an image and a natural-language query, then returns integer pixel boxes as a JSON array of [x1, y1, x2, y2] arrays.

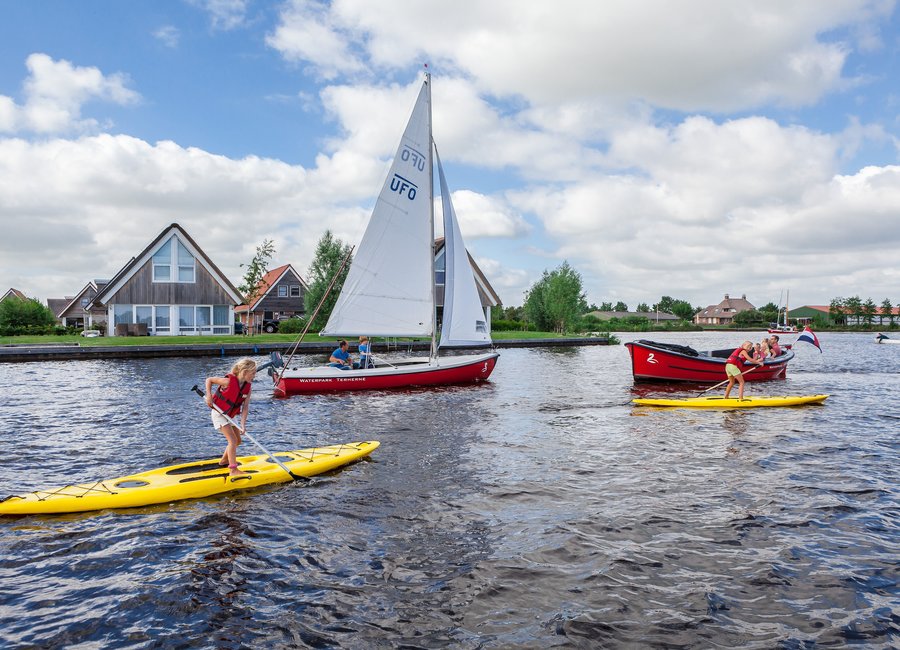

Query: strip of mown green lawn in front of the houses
[[0, 331, 604, 347]]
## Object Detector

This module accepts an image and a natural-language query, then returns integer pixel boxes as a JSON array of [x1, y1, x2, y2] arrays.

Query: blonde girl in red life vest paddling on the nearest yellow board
[[206, 359, 256, 476]]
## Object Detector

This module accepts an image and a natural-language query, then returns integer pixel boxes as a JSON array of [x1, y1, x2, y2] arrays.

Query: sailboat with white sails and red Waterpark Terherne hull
[[273, 73, 500, 395]]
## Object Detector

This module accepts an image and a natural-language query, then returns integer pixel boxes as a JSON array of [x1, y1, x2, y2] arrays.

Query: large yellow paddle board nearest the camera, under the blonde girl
[[0, 440, 380, 515]]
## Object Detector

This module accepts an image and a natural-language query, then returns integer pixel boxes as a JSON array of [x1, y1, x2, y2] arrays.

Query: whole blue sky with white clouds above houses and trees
[[0, 0, 900, 309]]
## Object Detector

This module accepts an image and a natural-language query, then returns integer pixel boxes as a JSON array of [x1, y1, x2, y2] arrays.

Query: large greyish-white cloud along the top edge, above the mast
[[269, 0, 892, 111]]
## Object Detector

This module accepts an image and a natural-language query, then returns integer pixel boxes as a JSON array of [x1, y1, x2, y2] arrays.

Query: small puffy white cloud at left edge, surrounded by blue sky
[[0, 54, 140, 133]]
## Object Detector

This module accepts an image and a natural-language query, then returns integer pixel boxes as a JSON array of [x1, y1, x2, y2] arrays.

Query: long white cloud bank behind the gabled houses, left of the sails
[[0, 135, 368, 298]]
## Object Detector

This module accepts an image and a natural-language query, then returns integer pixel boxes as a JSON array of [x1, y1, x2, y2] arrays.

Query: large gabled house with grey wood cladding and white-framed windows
[[88, 223, 244, 336]]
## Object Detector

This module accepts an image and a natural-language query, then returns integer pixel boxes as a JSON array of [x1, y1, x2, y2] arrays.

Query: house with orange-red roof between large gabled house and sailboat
[[235, 264, 309, 333]]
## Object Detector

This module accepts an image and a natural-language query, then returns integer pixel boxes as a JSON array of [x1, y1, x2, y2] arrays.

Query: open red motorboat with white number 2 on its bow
[[625, 340, 794, 384]]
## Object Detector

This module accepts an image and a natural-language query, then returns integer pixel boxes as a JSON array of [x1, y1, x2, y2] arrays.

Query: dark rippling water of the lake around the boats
[[0, 333, 900, 648]]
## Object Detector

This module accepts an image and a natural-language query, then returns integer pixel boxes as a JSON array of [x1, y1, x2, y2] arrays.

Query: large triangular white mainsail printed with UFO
[[322, 78, 434, 337]]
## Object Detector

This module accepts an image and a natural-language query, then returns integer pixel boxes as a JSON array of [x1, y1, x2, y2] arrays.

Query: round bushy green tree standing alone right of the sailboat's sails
[[525, 262, 587, 334]]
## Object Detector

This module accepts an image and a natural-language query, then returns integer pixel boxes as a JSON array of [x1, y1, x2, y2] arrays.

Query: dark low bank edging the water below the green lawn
[[0, 336, 610, 363]]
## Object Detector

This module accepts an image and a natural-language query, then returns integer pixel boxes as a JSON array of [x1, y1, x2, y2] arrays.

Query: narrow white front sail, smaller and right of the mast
[[435, 149, 491, 346]]
